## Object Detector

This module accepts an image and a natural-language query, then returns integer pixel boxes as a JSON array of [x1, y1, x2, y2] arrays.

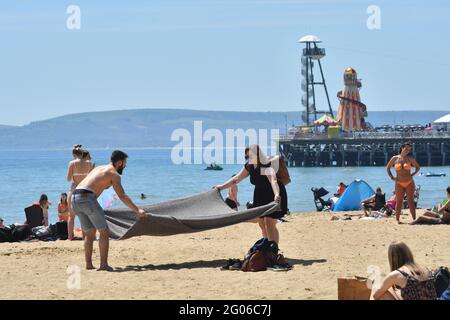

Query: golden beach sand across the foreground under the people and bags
[[0, 213, 450, 299]]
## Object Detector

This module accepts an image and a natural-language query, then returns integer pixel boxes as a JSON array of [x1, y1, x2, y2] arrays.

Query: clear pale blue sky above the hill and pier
[[0, 0, 450, 125]]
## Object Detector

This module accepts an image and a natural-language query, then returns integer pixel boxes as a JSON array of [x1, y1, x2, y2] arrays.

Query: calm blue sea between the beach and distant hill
[[0, 149, 450, 224]]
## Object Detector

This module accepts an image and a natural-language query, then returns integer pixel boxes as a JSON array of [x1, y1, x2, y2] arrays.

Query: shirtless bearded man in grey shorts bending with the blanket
[[72, 150, 146, 271]]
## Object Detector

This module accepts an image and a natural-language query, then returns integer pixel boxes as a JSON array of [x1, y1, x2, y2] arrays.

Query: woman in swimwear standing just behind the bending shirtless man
[[67, 144, 94, 240]]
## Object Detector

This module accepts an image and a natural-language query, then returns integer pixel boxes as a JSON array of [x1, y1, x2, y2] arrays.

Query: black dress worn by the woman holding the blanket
[[244, 163, 288, 219]]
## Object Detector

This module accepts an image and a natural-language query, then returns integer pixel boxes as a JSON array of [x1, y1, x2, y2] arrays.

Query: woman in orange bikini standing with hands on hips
[[386, 143, 420, 223]]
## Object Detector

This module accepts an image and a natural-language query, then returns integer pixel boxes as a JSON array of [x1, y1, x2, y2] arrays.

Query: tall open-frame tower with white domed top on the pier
[[298, 35, 334, 126]]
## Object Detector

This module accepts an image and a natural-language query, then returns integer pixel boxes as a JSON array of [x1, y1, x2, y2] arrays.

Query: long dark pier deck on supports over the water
[[279, 132, 450, 167]]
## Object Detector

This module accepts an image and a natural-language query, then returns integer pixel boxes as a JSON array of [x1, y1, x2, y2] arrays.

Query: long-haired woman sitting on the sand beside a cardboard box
[[372, 242, 437, 300]]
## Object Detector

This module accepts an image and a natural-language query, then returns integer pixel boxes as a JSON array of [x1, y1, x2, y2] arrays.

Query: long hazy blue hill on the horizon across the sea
[[0, 109, 446, 149]]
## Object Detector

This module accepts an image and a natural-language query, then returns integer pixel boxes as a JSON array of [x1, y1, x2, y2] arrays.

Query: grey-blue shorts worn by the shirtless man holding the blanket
[[72, 193, 108, 231]]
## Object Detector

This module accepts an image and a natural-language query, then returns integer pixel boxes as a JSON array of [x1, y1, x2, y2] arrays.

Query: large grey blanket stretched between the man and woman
[[105, 189, 279, 240]]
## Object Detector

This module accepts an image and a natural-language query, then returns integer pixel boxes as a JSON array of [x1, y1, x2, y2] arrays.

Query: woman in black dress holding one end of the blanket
[[215, 145, 288, 244]]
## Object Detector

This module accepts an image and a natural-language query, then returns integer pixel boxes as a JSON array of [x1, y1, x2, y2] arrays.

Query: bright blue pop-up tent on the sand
[[333, 180, 375, 211]]
